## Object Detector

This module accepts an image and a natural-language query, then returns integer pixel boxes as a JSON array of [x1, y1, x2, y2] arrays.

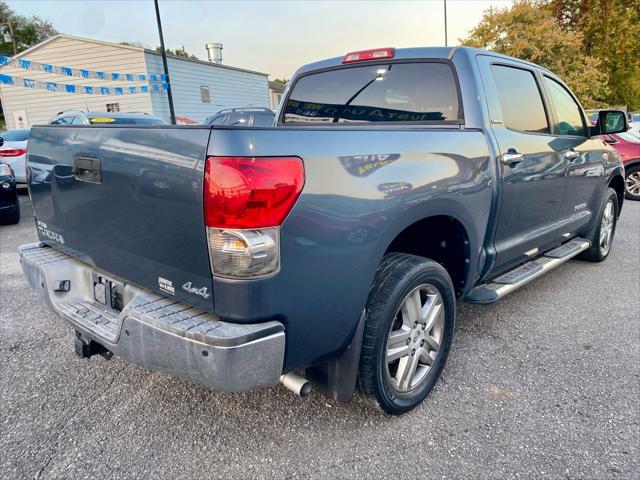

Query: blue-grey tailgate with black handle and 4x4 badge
[[28, 125, 213, 310]]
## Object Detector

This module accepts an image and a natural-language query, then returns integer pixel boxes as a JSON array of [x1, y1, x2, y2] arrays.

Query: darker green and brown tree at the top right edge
[[545, 0, 640, 110]]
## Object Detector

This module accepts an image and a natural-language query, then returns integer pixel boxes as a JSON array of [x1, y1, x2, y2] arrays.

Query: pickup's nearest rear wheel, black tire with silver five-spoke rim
[[358, 253, 455, 415]]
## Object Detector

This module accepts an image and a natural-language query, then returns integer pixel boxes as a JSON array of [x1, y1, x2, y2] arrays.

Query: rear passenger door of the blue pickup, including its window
[[478, 56, 566, 274]]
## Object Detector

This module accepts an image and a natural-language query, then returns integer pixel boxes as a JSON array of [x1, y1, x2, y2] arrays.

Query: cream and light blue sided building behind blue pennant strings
[[0, 35, 271, 129]]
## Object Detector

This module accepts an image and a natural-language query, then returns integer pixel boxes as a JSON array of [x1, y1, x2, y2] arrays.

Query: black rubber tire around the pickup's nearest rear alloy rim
[[358, 253, 456, 415]]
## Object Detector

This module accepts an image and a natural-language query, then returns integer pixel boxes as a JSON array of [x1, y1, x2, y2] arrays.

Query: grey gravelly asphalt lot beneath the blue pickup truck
[[0, 191, 640, 479]]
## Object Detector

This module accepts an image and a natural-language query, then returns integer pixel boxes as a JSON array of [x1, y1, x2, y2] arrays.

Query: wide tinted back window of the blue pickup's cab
[[283, 62, 460, 124]]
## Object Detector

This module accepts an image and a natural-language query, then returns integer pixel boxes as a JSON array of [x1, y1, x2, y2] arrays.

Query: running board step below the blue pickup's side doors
[[465, 238, 591, 303]]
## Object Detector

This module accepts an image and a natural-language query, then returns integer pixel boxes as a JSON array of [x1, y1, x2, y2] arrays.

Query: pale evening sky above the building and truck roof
[[7, 0, 512, 79]]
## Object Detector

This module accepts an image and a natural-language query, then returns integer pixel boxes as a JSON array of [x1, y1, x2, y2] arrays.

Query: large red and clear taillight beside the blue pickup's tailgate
[[204, 157, 304, 278]]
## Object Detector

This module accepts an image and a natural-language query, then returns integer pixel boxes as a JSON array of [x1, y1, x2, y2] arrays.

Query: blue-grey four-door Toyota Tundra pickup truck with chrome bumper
[[20, 48, 627, 414]]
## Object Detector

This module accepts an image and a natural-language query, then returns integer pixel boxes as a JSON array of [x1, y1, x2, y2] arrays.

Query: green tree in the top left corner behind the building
[[0, 1, 58, 56]]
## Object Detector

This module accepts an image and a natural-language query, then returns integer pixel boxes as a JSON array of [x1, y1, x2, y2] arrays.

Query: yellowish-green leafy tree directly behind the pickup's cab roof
[[461, 0, 611, 108]]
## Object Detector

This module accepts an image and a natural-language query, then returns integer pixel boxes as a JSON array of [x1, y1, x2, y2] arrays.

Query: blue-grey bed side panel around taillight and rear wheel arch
[[208, 127, 492, 367]]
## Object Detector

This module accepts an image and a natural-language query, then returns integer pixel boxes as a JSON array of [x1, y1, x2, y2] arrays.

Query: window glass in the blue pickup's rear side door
[[491, 65, 550, 133]]
